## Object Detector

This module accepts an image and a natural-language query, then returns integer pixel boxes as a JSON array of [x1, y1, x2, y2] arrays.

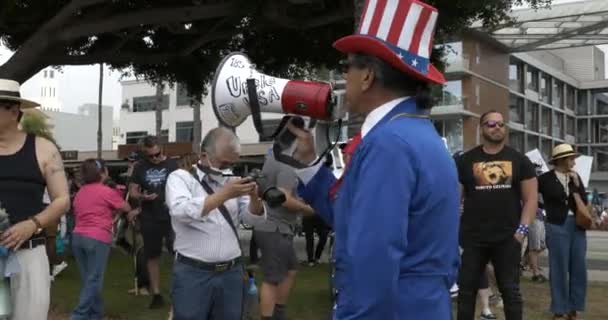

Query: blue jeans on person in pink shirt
[[70, 234, 110, 320]]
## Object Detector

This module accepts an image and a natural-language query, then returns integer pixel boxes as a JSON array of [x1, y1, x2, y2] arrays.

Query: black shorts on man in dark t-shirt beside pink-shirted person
[[140, 219, 175, 259]]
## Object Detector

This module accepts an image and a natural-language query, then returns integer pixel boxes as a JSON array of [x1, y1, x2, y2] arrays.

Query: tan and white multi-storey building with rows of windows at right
[[434, 36, 608, 191]]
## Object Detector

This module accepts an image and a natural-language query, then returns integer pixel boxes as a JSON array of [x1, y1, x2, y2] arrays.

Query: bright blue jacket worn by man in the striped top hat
[[299, 99, 460, 320]]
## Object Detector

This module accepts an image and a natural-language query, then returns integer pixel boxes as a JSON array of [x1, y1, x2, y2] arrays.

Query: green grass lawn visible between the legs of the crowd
[[49, 251, 608, 320]]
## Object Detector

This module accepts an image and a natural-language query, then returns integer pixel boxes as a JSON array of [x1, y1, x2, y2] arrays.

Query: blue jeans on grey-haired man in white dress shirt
[[171, 261, 245, 320]]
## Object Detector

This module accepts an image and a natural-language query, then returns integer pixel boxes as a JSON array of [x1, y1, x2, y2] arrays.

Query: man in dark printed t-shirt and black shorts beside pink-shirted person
[[129, 136, 177, 309]]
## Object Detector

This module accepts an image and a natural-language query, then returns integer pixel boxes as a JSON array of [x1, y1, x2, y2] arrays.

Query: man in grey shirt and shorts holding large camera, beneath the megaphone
[[255, 154, 314, 320]]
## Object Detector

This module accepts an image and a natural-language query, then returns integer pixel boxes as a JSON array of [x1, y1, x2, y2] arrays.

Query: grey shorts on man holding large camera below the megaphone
[[254, 231, 298, 285]]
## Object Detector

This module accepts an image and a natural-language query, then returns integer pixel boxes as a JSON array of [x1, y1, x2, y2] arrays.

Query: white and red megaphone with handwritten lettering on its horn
[[211, 52, 342, 130]]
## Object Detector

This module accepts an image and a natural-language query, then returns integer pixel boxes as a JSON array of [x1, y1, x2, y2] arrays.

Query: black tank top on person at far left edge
[[0, 134, 46, 224]]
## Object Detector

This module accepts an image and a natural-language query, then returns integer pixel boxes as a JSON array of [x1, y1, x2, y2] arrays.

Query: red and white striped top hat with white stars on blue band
[[334, 0, 445, 84]]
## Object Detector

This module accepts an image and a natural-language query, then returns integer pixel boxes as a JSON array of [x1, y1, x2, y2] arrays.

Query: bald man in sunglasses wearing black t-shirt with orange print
[[457, 111, 538, 320]]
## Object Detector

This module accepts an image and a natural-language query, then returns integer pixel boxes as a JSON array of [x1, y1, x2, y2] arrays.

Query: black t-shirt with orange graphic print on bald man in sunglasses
[[457, 146, 536, 245]]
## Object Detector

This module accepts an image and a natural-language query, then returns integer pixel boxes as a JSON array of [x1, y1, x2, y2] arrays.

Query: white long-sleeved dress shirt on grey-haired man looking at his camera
[[165, 168, 266, 263]]
